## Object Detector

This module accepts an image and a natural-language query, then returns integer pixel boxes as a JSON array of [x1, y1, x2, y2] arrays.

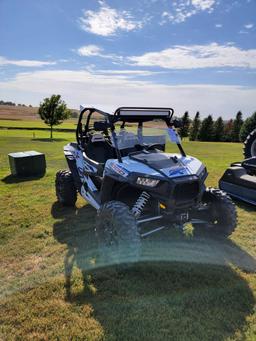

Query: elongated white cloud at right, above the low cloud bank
[[128, 43, 256, 69]]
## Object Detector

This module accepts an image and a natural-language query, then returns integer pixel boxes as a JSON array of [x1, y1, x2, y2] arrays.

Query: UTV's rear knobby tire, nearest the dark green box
[[55, 170, 77, 206]]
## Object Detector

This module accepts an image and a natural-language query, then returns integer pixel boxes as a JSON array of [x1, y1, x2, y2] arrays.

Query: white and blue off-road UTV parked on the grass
[[56, 107, 236, 245]]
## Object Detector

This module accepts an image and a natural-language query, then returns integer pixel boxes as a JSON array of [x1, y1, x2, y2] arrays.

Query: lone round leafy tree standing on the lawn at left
[[38, 95, 71, 139]]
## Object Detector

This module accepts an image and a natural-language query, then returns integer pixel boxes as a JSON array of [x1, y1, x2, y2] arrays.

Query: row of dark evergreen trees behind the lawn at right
[[179, 111, 256, 142]]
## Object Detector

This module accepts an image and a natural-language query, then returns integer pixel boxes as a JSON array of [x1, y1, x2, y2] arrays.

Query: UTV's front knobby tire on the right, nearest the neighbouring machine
[[194, 188, 237, 237]]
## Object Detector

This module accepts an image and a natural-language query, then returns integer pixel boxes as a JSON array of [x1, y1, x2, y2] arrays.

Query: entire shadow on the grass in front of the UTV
[[52, 203, 256, 340]]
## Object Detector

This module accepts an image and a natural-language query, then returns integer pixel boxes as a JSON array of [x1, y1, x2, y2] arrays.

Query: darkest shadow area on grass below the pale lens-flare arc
[[70, 262, 255, 341]]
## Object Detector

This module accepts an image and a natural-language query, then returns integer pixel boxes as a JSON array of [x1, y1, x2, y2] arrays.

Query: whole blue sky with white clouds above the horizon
[[0, 0, 256, 118]]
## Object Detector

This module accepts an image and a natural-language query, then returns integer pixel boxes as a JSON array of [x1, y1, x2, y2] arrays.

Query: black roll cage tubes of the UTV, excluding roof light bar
[[76, 107, 186, 162]]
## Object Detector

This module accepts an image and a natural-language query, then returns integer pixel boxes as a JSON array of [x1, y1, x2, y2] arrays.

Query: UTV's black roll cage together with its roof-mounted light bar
[[76, 107, 186, 162]]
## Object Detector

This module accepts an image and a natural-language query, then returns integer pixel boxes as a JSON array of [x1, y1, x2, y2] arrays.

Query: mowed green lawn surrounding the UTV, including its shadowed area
[[0, 126, 256, 341]]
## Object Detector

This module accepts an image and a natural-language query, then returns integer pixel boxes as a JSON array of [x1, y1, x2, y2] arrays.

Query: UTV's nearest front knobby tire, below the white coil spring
[[96, 201, 140, 263]]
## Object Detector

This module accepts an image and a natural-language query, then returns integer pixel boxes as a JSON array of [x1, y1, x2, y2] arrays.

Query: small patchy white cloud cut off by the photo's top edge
[[161, 0, 216, 24]]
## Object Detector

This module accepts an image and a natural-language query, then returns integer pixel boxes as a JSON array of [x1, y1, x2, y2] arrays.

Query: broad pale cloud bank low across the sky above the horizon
[[0, 70, 256, 118]]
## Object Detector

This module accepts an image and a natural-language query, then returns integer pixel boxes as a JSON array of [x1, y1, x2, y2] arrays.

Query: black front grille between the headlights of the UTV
[[173, 181, 199, 204]]
